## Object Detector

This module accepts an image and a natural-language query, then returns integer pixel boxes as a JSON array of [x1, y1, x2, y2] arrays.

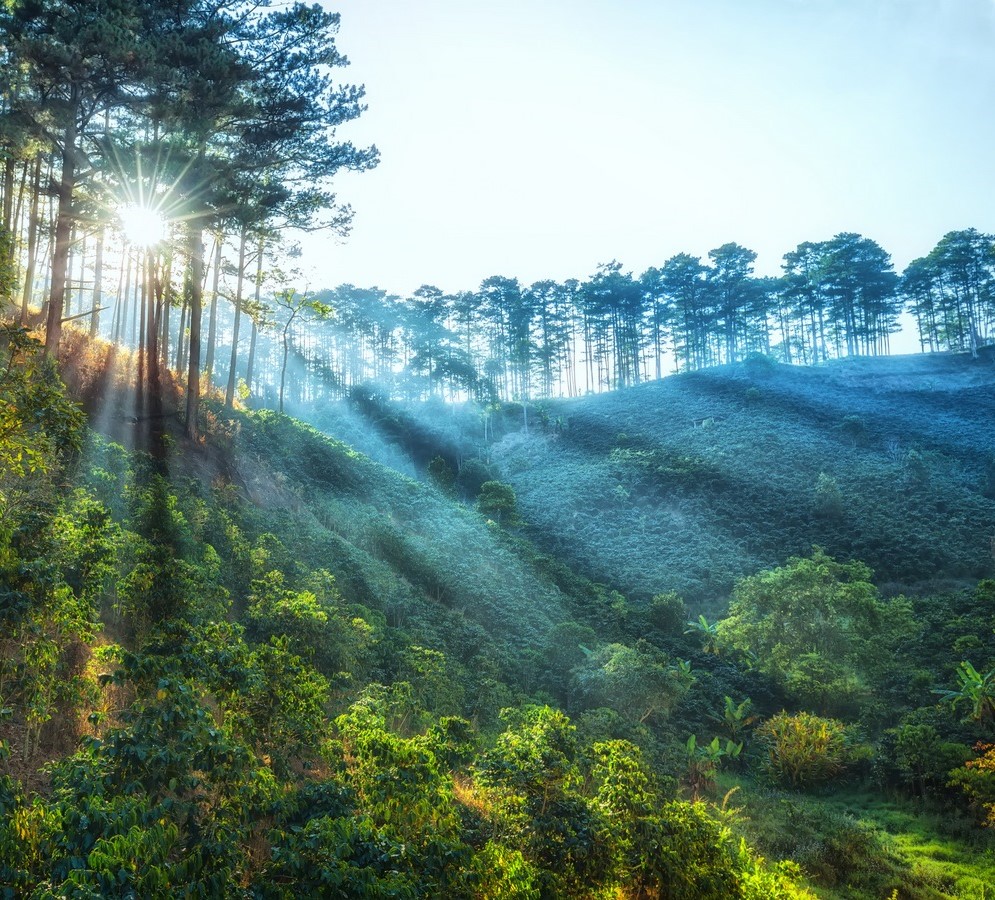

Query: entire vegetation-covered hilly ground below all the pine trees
[[0, 329, 995, 900]]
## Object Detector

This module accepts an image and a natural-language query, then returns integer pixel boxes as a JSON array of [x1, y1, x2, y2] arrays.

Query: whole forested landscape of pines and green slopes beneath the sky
[[0, 0, 995, 900]]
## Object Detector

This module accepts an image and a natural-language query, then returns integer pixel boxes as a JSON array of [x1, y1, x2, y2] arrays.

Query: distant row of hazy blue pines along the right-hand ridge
[[306, 229, 995, 401]]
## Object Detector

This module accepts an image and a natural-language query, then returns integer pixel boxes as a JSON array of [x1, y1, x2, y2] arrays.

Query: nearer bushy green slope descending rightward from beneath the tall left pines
[[0, 329, 791, 897]]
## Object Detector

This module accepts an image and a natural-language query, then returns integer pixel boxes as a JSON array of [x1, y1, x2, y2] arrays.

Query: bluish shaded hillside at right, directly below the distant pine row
[[476, 355, 995, 603]]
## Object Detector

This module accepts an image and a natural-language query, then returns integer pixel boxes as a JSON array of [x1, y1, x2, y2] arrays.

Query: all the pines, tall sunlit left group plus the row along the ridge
[[0, 0, 995, 424]]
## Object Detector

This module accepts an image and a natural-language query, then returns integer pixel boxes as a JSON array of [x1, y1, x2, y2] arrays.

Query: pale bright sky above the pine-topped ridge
[[303, 0, 995, 306]]
